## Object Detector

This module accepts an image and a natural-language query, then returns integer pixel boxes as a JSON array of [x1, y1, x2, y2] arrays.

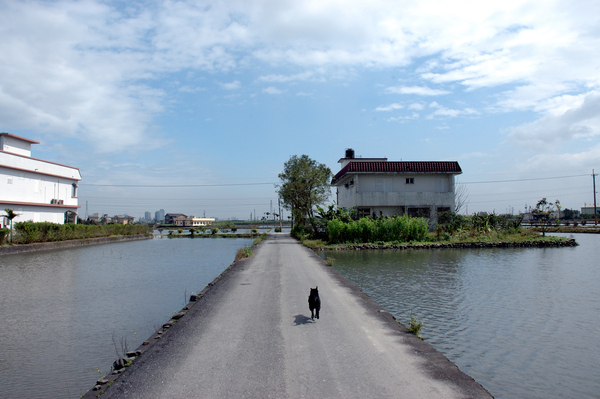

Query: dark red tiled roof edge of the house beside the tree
[[331, 161, 462, 184]]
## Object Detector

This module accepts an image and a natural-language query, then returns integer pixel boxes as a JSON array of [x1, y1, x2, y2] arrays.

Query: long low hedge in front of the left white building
[[14, 222, 149, 244]]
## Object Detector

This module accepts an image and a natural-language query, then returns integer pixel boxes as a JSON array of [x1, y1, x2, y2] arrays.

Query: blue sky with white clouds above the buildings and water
[[0, 0, 600, 220]]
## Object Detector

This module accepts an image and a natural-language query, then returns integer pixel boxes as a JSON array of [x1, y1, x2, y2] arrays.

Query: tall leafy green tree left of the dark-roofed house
[[277, 155, 333, 233]]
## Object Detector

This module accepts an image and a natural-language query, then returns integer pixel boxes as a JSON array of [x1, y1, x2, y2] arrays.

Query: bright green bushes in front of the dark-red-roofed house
[[327, 215, 429, 244]]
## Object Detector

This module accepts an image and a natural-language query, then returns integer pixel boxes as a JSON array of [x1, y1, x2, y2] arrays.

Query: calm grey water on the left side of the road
[[0, 238, 252, 398]]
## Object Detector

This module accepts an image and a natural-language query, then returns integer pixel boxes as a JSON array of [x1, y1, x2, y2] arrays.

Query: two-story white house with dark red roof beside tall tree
[[331, 149, 462, 222]]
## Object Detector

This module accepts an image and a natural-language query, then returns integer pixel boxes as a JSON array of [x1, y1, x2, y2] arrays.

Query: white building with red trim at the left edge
[[0, 133, 81, 224]]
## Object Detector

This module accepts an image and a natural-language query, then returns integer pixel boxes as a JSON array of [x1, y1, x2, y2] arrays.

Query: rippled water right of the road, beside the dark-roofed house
[[321, 234, 600, 398]]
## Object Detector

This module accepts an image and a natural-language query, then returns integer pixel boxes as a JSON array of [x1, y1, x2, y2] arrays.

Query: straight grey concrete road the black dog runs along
[[101, 234, 491, 399]]
